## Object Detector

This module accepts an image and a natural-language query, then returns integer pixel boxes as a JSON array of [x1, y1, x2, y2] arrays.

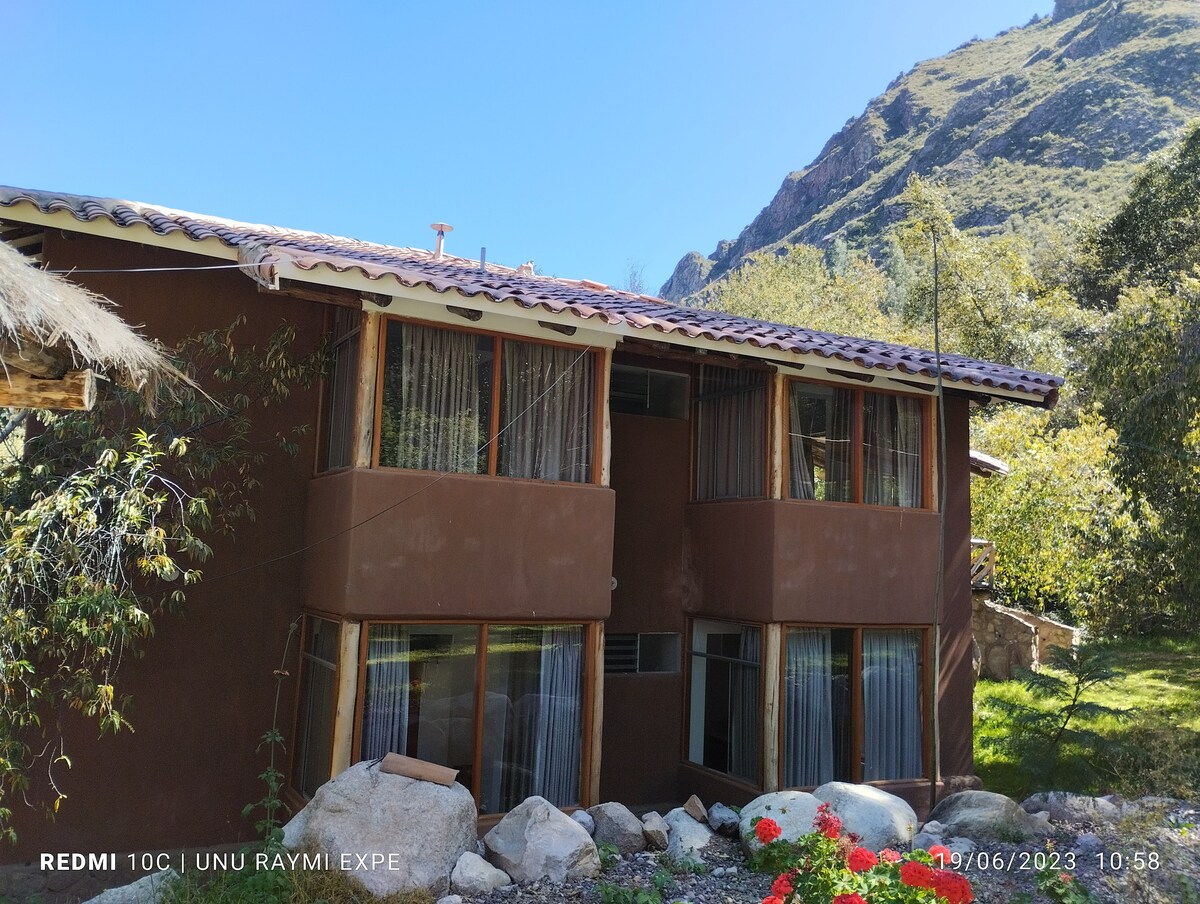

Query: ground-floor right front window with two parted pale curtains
[[782, 628, 925, 788]]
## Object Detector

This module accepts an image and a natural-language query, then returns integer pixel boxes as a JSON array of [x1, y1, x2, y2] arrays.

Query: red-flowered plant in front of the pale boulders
[[750, 803, 974, 904]]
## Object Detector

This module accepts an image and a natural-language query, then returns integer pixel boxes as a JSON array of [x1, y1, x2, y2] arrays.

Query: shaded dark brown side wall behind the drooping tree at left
[[8, 231, 323, 862]]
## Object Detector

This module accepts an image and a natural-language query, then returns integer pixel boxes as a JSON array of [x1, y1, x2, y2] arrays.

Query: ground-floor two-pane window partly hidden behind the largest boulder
[[359, 623, 584, 813]]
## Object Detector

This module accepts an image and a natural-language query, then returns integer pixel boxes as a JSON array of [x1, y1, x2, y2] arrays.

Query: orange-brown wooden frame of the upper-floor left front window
[[371, 315, 607, 486]]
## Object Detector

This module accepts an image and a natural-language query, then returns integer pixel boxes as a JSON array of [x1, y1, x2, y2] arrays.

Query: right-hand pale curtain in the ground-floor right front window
[[863, 630, 924, 782]]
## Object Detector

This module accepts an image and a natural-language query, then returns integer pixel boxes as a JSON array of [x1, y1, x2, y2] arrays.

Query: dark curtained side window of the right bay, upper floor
[[694, 365, 767, 499]]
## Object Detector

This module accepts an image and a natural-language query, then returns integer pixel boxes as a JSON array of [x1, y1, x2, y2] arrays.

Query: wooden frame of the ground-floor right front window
[[775, 619, 934, 791]]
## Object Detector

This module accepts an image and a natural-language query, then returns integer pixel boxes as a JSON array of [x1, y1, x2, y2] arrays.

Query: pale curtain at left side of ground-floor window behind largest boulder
[[361, 624, 409, 760]]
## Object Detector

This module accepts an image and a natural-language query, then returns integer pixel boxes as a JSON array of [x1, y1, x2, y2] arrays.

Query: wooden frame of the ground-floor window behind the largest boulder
[[350, 618, 604, 819]]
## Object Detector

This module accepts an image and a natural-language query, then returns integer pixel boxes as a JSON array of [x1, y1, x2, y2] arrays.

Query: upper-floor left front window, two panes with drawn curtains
[[379, 321, 596, 483]]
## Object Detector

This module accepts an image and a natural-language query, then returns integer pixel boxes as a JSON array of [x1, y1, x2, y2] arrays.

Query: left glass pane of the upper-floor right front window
[[788, 383, 853, 502]]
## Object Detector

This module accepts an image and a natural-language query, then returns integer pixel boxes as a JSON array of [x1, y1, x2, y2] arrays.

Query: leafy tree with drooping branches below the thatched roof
[[0, 321, 323, 838]]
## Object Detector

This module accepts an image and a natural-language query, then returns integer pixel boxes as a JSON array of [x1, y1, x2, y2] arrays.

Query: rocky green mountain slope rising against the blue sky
[[659, 0, 1200, 300]]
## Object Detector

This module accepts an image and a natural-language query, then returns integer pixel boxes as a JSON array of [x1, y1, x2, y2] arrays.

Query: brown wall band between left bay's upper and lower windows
[[305, 469, 613, 622]]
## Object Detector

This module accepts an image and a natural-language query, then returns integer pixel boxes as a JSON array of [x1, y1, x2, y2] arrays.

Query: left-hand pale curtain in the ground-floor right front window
[[784, 628, 834, 788]]
